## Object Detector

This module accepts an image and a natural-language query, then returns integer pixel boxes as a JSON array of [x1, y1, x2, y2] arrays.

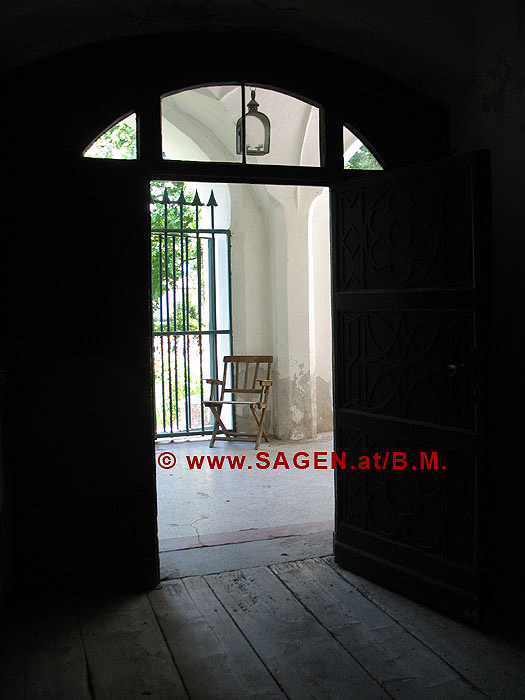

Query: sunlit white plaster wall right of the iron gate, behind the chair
[[231, 185, 332, 440]]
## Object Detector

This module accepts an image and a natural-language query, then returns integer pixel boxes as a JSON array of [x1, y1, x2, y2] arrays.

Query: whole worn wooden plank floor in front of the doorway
[[0, 557, 525, 700]]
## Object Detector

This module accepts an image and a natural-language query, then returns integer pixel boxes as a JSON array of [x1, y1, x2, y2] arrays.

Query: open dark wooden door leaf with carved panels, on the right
[[332, 153, 489, 619]]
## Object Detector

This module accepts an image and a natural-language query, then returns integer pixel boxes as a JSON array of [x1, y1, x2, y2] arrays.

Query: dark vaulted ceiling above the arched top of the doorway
[[0, 0, 486, 102]]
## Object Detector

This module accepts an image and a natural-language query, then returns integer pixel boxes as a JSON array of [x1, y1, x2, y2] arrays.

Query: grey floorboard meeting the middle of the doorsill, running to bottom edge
[[206, 567, 390, 700]]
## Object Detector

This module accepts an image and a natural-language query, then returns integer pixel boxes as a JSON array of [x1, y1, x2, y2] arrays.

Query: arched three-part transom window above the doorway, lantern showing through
[[83, 84, 381, 170]]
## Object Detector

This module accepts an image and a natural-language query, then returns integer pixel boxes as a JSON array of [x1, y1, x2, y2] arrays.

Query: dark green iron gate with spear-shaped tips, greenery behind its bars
[[150, 181, 232, 437]]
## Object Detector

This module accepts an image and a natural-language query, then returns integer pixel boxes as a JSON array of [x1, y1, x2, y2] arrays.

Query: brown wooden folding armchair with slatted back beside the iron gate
[[204, 355, 273, 450]]
